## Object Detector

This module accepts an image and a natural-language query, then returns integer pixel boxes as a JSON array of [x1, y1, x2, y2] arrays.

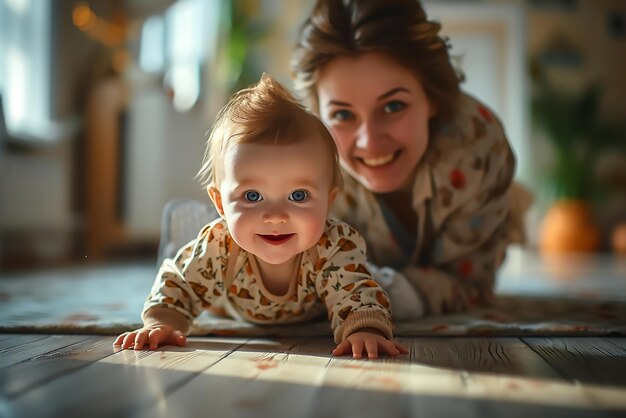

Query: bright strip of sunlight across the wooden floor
[[101, 339, 626, 410]]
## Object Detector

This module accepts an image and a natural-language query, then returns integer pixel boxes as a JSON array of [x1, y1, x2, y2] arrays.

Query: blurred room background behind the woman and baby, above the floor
[[0, 0, 626, 272]]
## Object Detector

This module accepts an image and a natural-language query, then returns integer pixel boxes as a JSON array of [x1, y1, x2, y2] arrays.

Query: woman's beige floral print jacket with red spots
[[333, 95, 531, 315]]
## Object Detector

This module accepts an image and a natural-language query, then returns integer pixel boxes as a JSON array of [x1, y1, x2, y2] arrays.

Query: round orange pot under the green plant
[[539, 200, 600, 253]]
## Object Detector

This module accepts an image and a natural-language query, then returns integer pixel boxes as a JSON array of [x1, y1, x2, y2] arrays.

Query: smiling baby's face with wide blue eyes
[[211, 137, 335, 264]]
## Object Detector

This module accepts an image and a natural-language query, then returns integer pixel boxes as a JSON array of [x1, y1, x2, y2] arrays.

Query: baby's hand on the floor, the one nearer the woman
[[333, 328, 409, 359]]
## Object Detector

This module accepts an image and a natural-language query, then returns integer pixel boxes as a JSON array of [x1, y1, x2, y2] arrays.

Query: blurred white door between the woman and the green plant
[[424, 0, 532, 183]]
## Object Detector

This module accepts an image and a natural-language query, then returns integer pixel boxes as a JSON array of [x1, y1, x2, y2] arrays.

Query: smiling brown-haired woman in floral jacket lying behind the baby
[[292, 0, 530, 319]]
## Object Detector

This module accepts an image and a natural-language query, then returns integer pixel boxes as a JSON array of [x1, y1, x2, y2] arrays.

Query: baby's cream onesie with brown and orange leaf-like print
[[142, 219, 392, 343]]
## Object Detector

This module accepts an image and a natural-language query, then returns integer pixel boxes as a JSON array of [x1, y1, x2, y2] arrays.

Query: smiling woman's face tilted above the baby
[[317, 53, 435, 193]]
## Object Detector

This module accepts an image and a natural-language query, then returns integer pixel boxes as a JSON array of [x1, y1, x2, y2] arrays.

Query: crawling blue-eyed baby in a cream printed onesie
[[114, 75, 407, 358]]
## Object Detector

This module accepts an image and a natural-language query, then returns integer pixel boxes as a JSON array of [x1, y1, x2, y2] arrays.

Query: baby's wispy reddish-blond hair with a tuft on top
[[196, 74, 341, 187]]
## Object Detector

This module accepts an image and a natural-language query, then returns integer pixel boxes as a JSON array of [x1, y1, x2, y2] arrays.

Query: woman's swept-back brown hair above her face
[[291, 0, 462, 128]]
